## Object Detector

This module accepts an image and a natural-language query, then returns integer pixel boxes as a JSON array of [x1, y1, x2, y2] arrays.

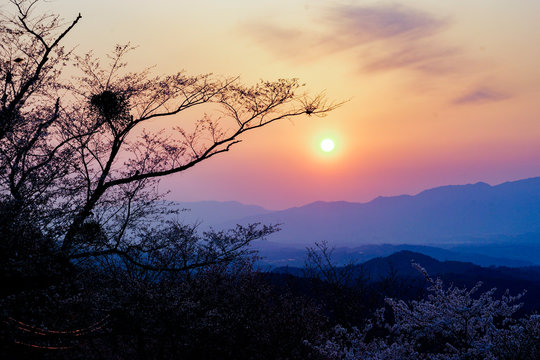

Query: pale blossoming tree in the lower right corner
[[315, 264, 540, 360]]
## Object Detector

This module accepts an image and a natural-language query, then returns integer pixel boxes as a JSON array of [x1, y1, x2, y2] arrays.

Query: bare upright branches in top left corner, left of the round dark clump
[[0, 0, 81, 141]]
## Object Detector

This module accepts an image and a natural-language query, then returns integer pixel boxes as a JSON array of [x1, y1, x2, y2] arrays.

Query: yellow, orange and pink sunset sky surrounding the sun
[[37, 0, 540, 209]]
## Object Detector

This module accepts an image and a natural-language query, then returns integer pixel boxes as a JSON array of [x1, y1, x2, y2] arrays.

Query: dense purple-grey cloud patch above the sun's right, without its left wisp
[[327, 5, 459, 73]]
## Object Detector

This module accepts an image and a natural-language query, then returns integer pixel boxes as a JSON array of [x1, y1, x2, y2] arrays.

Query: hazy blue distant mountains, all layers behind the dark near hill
[[170, 177, 540, 266]]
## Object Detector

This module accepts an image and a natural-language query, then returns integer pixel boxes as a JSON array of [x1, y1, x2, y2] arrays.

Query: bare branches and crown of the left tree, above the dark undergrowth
[[0, 0, 339, 270]]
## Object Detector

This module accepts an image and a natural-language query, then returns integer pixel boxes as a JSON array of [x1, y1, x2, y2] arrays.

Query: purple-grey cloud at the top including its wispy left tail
[[244, 5, 460, 73]]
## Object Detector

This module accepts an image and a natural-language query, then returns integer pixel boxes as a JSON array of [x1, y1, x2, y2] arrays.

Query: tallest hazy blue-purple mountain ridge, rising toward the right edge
[[218, 177, 540, 246]]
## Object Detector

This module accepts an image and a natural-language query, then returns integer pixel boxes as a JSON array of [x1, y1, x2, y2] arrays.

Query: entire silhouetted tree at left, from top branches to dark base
[[0, 0, 338, 357]]
